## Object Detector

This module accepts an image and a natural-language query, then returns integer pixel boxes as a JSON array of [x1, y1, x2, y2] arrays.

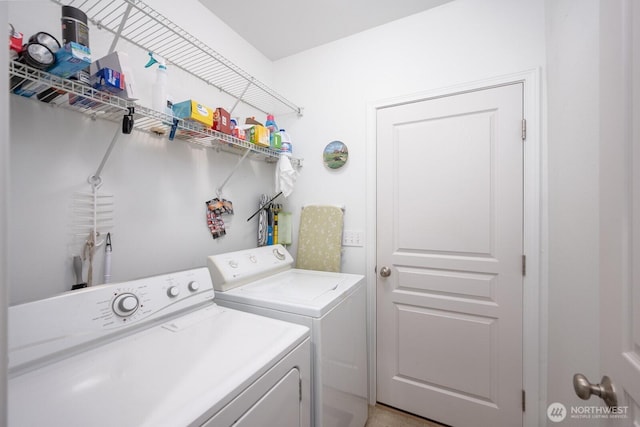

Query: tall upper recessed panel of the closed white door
[[394, 112, 495, 254]]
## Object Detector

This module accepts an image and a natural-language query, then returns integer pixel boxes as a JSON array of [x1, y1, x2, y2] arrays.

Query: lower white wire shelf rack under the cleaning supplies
[[9, 61, 302, 166]]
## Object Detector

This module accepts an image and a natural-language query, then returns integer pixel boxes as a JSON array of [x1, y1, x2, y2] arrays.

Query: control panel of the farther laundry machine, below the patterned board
[[207, 245, 293, 292]]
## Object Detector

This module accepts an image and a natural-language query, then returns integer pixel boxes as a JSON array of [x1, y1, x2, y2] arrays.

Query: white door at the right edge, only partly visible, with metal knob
[[596, 0, 640, 427]]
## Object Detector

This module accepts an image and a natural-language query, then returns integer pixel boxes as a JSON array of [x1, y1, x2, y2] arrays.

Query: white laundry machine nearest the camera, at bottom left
[[8, 268, 311, 427]]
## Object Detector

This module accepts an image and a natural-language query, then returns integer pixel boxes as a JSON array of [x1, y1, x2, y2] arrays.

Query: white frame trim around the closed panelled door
[[365, 69, 548, 427]]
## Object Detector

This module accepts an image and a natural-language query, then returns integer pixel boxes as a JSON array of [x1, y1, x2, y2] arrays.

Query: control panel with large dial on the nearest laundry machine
[[9, 268, 214, 369]]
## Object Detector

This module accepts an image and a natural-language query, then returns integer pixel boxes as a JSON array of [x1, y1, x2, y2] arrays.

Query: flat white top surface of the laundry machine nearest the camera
[[8, 304, 309, 427]]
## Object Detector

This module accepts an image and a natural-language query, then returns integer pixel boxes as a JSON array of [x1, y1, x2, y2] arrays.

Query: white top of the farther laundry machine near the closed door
[[215, 269, 364, 317]]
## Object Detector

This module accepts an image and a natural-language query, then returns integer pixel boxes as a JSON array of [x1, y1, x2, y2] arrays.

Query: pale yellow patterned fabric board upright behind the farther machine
[[296, 206, 344, 272]]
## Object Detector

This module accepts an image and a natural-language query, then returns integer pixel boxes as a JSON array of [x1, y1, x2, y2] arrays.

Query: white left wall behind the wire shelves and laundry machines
[[3, 0, 284, 304]]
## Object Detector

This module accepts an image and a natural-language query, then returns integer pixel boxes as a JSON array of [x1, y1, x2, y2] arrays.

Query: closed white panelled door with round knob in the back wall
[[376, 83, 523, 427]]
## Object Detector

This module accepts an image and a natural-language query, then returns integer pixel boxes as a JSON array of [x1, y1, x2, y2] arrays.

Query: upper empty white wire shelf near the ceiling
[[51, 0, 302, 116]]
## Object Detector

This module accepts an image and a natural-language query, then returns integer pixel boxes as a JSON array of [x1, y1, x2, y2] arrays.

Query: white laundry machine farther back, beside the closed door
[[208, 245, 368, 427]]
